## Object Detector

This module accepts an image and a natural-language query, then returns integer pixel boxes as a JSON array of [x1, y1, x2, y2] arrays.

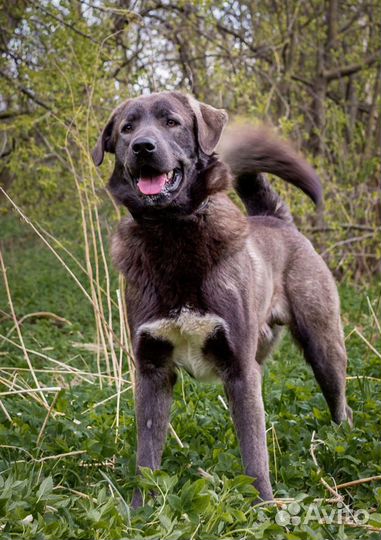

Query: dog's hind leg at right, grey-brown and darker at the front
[[288, 253, 352, 424]]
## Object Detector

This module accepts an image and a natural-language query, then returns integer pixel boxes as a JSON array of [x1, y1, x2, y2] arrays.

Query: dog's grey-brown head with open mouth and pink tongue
[[93, 92, 227, 214]]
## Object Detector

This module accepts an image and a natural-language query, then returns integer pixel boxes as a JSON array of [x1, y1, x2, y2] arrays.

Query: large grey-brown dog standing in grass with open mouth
[[93, 92, 352, 507]]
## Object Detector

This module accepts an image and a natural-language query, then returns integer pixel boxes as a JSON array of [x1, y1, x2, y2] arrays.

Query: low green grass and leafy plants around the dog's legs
[[0, 213, 381, 540]]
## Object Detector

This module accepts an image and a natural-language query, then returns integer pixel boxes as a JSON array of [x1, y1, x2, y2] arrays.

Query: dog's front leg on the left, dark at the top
[[132, 336, 176, 507]]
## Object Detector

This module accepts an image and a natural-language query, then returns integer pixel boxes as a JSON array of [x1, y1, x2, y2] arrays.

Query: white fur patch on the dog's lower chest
[[138, 308, 227, 382]]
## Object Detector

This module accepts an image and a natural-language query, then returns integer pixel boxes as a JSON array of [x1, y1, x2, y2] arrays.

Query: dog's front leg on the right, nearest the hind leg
[[224, 359, 273, 500]]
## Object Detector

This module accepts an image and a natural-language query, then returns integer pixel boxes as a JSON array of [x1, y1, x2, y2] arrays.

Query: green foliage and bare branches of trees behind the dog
[[0, 0, 381, 279]]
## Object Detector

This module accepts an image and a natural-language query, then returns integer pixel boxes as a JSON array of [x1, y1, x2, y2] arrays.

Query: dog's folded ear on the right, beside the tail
[[189, 96, 228, 156]]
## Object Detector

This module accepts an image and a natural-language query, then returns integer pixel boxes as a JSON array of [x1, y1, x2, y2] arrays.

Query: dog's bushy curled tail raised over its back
[[219, 125, 323, 222]]
